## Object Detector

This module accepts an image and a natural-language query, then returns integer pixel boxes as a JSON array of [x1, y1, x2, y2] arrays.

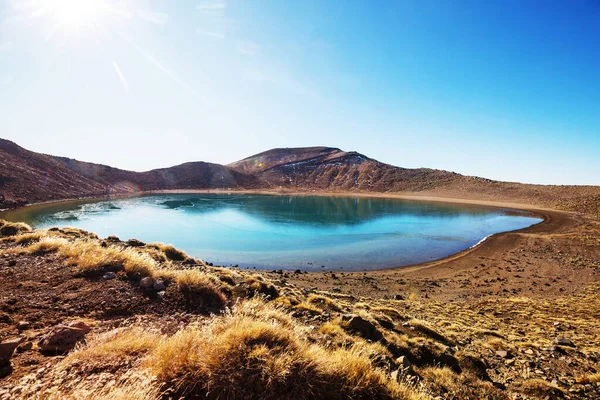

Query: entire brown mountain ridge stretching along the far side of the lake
[[0, 139, 600, 213]]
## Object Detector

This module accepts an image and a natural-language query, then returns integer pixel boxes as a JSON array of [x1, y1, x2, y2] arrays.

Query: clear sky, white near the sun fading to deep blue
[[0, 0, 600, 185]]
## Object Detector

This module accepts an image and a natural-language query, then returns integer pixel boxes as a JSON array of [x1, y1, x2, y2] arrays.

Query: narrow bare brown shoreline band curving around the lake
[[4, 189, 571, 274]]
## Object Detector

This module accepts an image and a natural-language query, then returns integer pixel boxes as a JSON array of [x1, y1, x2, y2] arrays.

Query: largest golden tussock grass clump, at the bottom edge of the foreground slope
[[146, 303, 423, 400]]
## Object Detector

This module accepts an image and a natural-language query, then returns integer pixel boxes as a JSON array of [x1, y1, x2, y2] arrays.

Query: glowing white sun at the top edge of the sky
[[42, 0, 110, 31]]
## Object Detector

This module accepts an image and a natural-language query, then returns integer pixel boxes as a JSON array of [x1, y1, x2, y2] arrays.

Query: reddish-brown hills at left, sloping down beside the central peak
[[0, 139, 265, 208]]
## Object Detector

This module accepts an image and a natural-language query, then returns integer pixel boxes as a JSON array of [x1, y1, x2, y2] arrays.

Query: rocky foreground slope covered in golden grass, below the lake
[[0, 222, 600, 400]]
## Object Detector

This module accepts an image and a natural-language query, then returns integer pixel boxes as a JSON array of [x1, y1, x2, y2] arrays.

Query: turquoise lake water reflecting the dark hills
[[0, 194, 541, 271]]
